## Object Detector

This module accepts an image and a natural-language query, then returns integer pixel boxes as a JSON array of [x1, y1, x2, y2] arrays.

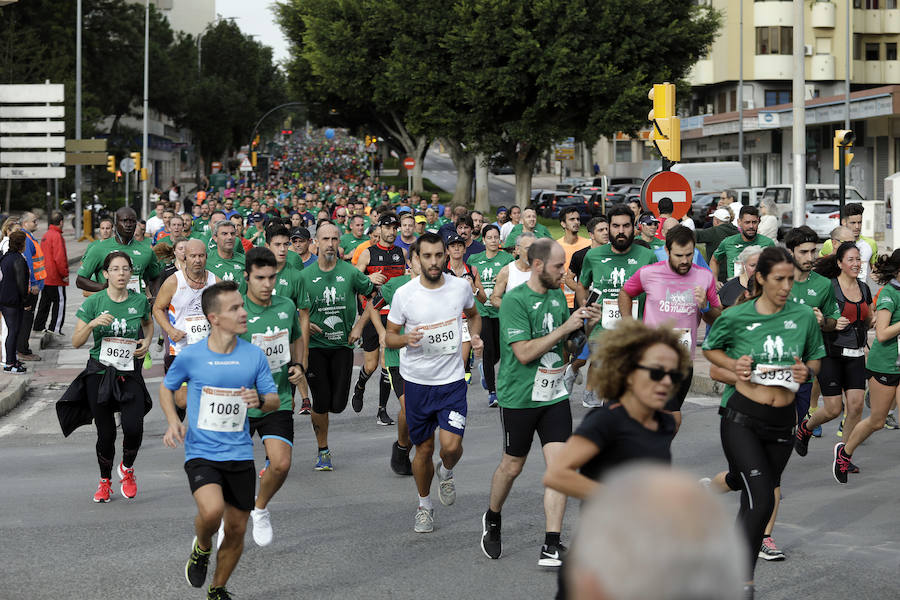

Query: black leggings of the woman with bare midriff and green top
[[720, 392, 796, 578]]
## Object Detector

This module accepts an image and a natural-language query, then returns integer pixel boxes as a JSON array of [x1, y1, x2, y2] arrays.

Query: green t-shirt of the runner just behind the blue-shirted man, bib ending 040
[[241, 296, 300, 418]]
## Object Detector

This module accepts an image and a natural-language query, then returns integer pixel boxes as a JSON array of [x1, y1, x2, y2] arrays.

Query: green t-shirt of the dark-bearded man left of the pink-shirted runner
[[578, 244, 657, 337]]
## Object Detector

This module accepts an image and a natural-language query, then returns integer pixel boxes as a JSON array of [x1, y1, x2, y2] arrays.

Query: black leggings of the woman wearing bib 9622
[[85, 373, 144, 479]]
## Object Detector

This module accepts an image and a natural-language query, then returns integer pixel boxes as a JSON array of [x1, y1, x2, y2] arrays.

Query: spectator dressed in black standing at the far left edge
[[0, 232, 29, 373]]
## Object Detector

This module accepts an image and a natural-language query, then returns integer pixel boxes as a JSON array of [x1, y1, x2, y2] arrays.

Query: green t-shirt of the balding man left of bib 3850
[[297, 260, 374, 348]]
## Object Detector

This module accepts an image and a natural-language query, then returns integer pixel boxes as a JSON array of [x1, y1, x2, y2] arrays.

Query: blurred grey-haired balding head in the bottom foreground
[[568, 465, 748, 600]]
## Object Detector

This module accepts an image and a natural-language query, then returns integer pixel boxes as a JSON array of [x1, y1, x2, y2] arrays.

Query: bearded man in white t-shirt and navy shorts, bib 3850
[[385, 233, 483, 533]]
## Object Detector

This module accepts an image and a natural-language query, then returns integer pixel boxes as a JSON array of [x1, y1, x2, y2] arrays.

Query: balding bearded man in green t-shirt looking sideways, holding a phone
[[481, 240, 602, 567]]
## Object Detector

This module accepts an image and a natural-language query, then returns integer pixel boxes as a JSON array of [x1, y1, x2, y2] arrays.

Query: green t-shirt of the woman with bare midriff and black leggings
[[703, 300, 828, 406]]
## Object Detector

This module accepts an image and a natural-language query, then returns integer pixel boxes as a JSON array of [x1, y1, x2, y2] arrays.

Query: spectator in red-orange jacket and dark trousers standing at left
[[32, 211, 69, 334]]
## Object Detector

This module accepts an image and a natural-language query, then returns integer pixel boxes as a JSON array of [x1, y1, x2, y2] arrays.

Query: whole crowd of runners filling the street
[[57, 132, 900, 598]]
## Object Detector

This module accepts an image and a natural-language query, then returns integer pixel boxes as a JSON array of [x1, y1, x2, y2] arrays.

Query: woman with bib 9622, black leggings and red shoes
[[66, 251, 153, 502]]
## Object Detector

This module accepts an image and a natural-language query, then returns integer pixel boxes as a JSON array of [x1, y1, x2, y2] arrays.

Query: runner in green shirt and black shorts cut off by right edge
[[832, 250, 900, 484]]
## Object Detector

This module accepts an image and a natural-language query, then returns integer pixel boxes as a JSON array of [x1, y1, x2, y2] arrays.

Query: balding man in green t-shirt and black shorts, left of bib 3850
[[298, 222, 378, 471]]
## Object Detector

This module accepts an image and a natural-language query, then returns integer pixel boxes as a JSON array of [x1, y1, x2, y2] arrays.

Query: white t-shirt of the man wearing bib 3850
[[388, 273, 475, 385]]
